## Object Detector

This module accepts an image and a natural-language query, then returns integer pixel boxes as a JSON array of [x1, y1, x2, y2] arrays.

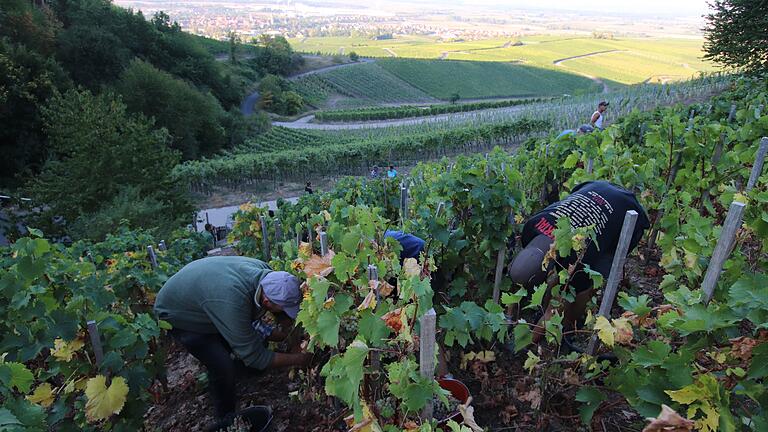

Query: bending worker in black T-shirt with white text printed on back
[[509, 181, 650, 339]]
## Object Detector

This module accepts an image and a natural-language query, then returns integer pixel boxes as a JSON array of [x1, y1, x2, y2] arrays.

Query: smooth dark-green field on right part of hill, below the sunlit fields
[[377, 59, 601, 99]]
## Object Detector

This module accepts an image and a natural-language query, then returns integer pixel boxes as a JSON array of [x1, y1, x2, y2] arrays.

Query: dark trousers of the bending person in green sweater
[[170, 328, 260, 419]]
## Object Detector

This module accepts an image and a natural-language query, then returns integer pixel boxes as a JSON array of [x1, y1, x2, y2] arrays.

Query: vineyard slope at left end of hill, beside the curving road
[[294, 63, 435, 107]]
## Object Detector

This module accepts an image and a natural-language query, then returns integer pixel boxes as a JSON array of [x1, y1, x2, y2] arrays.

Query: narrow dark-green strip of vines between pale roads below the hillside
[[315, 98, 543, 122]]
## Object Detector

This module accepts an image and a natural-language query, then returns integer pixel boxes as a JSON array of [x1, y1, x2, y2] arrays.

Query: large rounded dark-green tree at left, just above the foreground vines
[[27, 90, 191, 240]]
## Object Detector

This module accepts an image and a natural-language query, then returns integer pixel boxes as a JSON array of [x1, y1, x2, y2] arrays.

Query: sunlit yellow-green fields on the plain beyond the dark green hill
[[290, 35, 715, 84]]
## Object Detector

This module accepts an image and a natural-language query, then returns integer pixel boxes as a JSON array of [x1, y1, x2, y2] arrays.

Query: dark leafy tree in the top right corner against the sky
[[704, 0, 768, 72]]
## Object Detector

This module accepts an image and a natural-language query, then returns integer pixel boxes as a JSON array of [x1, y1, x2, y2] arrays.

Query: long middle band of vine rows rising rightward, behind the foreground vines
[[174, 75, 730, 193]]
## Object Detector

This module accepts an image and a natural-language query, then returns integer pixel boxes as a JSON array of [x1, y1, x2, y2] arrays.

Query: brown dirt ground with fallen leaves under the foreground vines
[[145, 249, 663, 432]]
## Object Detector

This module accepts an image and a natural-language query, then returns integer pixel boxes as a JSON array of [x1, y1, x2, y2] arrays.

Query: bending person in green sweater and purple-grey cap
[[155, 256, 312, 430]]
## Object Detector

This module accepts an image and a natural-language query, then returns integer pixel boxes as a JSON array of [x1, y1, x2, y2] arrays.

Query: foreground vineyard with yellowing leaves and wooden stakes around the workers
[[0, 72, 768, 432]]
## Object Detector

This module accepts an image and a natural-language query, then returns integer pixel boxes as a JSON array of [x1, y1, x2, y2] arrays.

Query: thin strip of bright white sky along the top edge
[[414, 0, 709, 16]]
